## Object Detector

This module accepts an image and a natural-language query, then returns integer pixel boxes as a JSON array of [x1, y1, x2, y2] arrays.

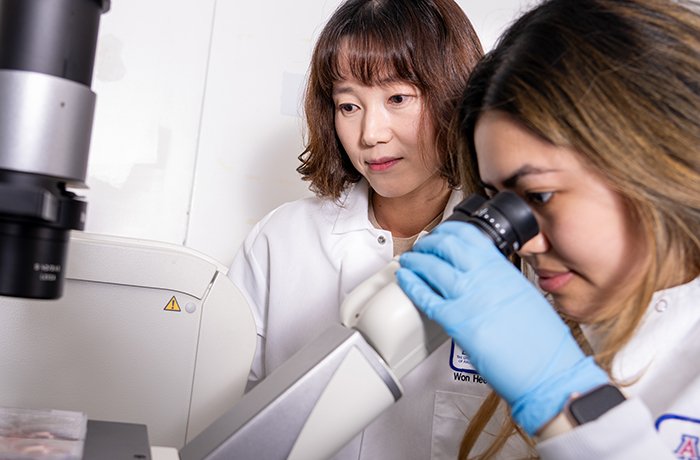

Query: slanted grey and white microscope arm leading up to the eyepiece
[[180, 261, 446, 460]]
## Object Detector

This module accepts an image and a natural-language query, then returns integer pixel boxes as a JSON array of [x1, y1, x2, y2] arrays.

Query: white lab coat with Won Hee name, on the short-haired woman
[[229, 181, 522, 460]]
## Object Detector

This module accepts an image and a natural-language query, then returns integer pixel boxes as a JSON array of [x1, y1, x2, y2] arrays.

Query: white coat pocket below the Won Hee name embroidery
[[430, 391, 530, 460]]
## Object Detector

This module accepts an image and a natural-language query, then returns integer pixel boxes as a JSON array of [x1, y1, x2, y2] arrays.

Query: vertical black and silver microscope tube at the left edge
[[0, 0, 110, 299]]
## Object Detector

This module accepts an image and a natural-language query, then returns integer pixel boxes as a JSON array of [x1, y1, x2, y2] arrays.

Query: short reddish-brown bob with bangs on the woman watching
[[297, 0, 483, 199]]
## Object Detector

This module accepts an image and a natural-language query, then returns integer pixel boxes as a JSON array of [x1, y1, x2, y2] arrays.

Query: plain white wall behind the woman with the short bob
[[84, 0, 533, 265]]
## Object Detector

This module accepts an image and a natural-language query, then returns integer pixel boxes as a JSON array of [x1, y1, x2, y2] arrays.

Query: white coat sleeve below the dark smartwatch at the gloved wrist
[[536, 399, 676, 460]]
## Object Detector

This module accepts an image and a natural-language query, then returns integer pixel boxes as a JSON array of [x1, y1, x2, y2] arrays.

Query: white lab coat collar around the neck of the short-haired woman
[[333, 179, 464, 234]]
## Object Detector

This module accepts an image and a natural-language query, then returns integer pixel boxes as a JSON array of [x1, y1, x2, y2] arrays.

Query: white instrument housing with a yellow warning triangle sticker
[[0, 232, 255, 448]]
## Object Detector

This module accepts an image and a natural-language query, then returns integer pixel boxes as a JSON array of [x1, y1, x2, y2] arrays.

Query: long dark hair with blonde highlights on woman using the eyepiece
[[454, 0, 700, 458]]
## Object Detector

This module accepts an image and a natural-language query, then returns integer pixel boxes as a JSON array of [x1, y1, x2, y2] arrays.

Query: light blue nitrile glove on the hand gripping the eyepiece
[[396, 222, 608, 435]]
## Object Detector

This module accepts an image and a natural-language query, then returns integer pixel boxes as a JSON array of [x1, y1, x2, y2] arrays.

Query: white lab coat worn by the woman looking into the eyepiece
[[537, 278, 700, 460]]
